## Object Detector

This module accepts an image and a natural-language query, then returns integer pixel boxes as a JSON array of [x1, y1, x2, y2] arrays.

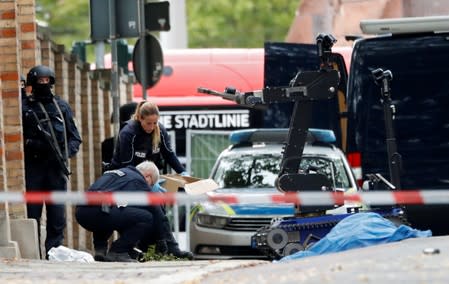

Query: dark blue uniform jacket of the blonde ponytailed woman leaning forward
[[112, 119, 185, 173]]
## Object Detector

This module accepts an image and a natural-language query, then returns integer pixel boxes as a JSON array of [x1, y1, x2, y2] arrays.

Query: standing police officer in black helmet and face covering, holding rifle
[[22, 65, 81, 256]]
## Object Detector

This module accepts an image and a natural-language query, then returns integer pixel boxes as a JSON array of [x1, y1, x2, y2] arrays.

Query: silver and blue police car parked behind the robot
[[189, 129, 357, 259]]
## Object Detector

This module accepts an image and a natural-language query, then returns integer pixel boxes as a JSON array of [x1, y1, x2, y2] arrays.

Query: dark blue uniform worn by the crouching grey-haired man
[[75, 166, 166, 258]]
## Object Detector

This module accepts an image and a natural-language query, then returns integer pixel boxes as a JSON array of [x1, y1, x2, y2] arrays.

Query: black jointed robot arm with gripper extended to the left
[[198, 34, 340, 192]]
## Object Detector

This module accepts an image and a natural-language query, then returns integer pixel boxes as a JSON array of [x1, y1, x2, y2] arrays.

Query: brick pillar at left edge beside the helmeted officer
[[0, 1, 28, 218]]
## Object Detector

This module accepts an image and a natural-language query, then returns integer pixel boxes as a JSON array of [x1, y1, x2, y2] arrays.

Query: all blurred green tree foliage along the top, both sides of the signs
[[36, 0, 300, 55]]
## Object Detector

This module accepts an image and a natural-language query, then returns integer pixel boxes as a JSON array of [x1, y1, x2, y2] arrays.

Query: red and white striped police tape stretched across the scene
[[0, 189, 449, 206]]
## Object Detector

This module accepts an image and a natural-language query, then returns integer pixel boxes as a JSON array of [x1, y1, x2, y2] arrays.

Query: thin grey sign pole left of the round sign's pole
[[109, 0, 120, 136]]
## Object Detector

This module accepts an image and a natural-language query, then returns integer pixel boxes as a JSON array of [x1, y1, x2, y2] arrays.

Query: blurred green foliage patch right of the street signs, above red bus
[[186, 0, 299, 47]]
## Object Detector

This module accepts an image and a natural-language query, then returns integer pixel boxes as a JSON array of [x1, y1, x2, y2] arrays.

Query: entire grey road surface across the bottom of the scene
[[0, 236, 449, 284]]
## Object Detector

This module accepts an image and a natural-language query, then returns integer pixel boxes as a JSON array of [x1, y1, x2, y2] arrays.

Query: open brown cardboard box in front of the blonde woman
[[161, 174, 218, 195]]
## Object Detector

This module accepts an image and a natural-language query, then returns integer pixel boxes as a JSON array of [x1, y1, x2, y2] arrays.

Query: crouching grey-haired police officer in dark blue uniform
[[75, 161, 192, 262]]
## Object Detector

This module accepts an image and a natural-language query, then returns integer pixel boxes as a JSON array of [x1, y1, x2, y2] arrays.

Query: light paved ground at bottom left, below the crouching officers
[[0, 259, 267, 284]]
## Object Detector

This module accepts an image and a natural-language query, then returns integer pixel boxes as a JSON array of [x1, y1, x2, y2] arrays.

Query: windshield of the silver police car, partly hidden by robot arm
[[212, 154, 350, 189]]
